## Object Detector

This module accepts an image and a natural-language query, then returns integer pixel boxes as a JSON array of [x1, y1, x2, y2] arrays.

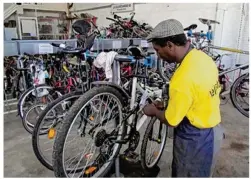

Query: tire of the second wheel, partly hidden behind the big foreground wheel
[[32, 91, 83, 170]]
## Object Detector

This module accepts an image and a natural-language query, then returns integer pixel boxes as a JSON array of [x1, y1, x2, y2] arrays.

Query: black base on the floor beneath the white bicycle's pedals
[[106, 155, 160, 178]]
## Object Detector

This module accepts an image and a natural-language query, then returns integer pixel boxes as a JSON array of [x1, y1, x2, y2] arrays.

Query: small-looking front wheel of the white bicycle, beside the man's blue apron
[[140, 117, 167, 171]]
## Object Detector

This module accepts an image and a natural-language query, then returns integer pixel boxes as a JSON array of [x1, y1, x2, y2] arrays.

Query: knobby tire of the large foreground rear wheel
[[52, 86, 125, 177]]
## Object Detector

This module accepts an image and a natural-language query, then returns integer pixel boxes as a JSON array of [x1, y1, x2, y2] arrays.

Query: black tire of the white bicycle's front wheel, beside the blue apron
[[140, 117, 167, 172]]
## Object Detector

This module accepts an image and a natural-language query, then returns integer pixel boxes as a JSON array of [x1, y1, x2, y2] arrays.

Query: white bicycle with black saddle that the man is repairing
[[53, 47, 167, 177]]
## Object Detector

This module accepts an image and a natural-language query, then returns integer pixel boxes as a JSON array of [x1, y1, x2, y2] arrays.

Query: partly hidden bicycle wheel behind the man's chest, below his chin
[[157, 57, 175, 82]]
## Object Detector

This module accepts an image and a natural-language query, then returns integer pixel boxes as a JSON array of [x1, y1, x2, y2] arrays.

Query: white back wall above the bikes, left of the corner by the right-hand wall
[[73, 3, 216, 30]]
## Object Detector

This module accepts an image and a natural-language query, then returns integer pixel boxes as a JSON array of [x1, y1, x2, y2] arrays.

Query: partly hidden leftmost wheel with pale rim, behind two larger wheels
[[17, 85, 62, 119]]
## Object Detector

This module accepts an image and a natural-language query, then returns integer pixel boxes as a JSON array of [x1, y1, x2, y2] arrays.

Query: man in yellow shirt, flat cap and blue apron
[[143, 19, 223, 177]]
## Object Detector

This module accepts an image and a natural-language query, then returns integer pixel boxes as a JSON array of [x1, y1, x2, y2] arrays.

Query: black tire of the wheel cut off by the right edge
[[230, 73, 249, 117]]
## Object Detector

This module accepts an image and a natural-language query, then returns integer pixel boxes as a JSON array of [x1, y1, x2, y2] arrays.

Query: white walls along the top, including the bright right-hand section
[[72, 3, 247, 48]]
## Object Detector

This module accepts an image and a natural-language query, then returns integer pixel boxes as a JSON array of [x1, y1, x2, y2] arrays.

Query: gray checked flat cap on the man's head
[[146, 19, 184, 41]]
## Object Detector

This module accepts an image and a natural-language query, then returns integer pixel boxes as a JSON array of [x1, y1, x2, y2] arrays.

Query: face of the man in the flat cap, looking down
[[153, 43, 175, 63]]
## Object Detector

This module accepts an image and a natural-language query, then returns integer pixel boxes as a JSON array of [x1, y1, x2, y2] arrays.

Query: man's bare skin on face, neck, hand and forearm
[[143, 42, 190, 127]]
